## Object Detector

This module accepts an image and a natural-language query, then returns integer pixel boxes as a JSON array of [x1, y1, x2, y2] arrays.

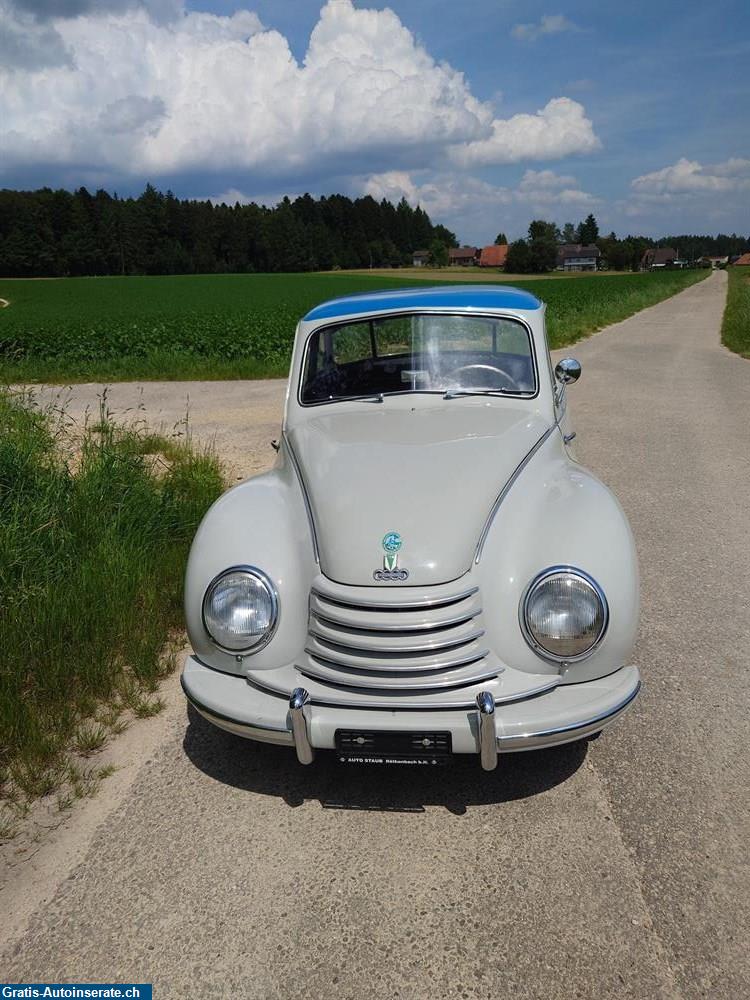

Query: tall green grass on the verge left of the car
[[0, 392, 222, 797]]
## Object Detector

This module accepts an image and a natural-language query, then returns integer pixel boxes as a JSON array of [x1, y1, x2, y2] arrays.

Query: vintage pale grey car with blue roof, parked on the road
[[182, 285, 640, 770]]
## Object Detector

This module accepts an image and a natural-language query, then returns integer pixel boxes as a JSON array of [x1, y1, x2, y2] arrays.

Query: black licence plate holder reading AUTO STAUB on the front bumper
[[336, 729, 453, 767]]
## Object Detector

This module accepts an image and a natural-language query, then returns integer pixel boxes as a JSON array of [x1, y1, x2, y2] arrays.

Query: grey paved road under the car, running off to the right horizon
[[0, 274, 750, 1000]]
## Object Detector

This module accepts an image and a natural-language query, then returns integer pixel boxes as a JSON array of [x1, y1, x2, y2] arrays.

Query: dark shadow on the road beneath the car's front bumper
[[183, 706, 587, 816]]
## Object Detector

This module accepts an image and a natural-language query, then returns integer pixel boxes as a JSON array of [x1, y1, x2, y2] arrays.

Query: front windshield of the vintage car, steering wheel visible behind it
[[300, 313, 536, 404]]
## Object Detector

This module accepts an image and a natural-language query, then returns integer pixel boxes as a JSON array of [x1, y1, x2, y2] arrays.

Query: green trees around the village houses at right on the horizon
[[505, 214, 750, 274]]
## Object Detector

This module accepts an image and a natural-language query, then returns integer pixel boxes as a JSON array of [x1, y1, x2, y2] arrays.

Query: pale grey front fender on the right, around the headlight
[[475, 433, 639, 683]]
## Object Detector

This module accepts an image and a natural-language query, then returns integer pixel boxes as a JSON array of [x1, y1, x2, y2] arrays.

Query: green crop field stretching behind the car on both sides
[[0, 271, 706, 382]]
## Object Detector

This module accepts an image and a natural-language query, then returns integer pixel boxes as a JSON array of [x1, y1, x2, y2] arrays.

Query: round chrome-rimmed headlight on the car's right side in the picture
[[521, 566, 609, 662]]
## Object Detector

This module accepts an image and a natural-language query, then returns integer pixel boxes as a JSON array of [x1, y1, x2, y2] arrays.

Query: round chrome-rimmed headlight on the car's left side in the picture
[[203, 566, 279, 653]]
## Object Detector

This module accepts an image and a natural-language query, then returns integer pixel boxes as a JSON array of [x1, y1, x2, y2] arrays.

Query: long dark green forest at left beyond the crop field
[[0, 185, 457, 277]]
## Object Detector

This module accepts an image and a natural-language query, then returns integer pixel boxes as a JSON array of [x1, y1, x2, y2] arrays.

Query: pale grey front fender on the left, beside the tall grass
[[185, 448, 317, 674]]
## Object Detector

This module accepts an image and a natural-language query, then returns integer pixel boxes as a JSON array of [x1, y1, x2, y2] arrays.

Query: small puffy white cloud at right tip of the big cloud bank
[[451, 97, 601, 166]]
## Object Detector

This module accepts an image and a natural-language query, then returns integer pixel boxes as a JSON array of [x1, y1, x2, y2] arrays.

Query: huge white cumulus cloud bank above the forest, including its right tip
[[0, 0, 599, 184]]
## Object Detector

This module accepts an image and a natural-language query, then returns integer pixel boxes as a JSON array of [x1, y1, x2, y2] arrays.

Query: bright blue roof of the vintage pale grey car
[[305, 285, 542, 321]]
